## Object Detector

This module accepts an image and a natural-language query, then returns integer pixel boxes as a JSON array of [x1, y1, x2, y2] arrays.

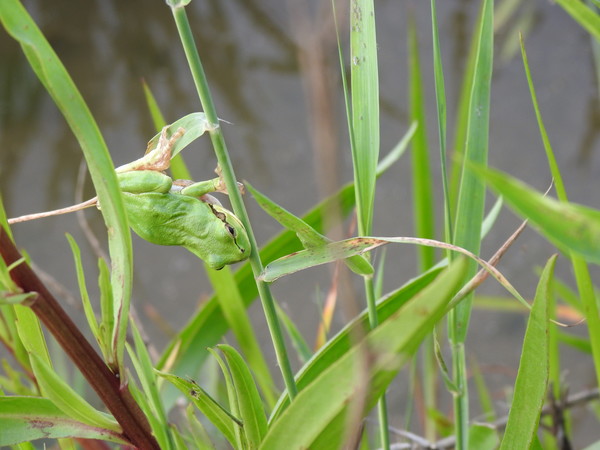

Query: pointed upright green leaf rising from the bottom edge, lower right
[[500, 255, 556, 450]]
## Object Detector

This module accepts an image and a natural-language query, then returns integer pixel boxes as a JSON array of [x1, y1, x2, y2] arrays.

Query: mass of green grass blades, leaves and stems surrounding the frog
[[0, 0, 600, 450]]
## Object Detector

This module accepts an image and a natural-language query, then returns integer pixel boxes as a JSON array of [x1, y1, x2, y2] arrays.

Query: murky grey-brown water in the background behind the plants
[[0, 0, 600, 444]]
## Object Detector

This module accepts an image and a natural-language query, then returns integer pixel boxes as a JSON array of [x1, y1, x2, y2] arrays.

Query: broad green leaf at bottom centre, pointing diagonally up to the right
[[260, 260, 466, 450]]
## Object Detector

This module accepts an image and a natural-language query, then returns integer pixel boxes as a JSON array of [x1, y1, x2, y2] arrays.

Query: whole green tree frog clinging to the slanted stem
[[117, 127, 251, 269]]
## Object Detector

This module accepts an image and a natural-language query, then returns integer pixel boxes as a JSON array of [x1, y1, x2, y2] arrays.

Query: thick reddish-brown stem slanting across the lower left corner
[[0, 227, 160, 450]]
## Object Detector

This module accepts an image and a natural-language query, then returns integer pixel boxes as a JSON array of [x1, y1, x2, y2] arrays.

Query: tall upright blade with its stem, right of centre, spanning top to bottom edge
[[448, 0, 494, 448]]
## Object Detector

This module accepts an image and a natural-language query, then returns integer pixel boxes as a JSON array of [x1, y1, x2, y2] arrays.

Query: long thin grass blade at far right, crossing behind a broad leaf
[[520, 36, 600, 388]]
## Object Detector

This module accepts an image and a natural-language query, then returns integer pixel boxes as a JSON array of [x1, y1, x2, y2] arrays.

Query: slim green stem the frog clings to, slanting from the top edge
[[169, 2, 298, 400]]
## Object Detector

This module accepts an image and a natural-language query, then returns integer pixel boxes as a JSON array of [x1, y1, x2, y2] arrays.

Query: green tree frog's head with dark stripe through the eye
[[203, 204, 252, 270]]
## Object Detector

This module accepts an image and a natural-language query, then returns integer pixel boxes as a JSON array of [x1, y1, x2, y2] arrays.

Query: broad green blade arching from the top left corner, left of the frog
[[0, 0, 132, 367]]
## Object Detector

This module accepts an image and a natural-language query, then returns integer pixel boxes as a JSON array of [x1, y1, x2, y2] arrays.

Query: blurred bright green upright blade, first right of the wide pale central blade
[[408, 15, 435, 272]]
